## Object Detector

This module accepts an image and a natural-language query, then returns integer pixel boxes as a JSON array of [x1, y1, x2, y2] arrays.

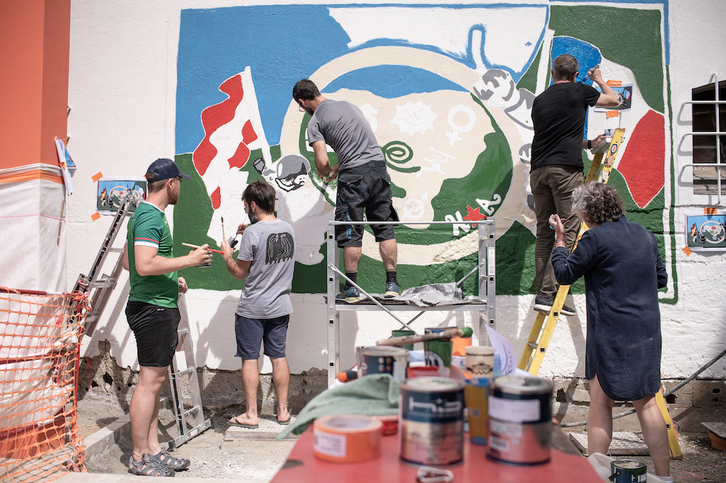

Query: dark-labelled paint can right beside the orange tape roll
[[398, 377, 464, 465]]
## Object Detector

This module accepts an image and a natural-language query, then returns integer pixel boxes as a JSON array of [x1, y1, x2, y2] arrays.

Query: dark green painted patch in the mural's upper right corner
[[549, 5, 665, 112]]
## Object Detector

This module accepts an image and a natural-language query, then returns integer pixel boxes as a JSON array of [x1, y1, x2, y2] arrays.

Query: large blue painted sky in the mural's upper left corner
[[176, 6, 350, 154]]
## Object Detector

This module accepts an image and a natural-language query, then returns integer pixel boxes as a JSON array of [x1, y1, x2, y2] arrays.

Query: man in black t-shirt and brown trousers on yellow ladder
[[529, 54, 619, 315]]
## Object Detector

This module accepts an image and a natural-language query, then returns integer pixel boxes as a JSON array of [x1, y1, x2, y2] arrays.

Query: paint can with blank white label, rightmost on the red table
[[487, 374, 554, 465]]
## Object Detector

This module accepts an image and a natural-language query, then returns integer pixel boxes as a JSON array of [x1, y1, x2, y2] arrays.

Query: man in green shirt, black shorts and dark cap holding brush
[[122, 158, 212, 476]]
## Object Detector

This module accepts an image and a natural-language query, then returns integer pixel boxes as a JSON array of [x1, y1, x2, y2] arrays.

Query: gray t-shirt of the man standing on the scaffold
[[308, 99, 386, 172]]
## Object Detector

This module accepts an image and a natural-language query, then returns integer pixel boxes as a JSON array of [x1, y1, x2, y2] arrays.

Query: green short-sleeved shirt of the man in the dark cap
[[126, 201, 179, 308]]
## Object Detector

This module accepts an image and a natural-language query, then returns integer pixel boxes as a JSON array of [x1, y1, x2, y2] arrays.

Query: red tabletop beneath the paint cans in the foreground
[[272, 426, 602, 483]]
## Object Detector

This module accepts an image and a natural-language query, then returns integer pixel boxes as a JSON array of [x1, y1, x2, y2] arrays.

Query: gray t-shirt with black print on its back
[[237, 220, 295, 319]]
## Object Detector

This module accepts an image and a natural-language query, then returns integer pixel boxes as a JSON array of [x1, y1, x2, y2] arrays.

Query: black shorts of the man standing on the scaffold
[[335, 161, 398, 247]]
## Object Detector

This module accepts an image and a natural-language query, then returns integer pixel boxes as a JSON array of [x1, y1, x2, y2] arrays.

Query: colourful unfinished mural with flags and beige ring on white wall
[[174, 2, 675, 295]]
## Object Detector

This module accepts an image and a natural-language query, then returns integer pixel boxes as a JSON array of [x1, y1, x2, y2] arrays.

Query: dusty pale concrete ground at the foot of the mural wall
[[56, 394, 726, 483]]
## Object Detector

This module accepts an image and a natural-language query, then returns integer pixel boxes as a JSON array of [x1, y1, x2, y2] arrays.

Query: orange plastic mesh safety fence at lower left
[[0, 287, 90, 482]]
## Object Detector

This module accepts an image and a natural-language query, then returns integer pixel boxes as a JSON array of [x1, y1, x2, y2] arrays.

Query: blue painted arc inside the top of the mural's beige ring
[[323, 65, 469, 99]]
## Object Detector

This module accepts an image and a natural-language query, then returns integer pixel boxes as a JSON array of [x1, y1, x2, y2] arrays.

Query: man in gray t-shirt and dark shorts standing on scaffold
[[292, 79, 401, 302]]
